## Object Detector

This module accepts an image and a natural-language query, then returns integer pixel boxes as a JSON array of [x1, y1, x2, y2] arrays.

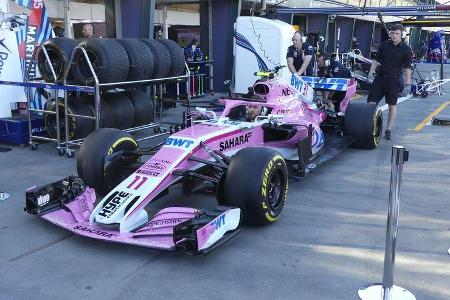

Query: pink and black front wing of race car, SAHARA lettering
[[25, 177, 241, 254]]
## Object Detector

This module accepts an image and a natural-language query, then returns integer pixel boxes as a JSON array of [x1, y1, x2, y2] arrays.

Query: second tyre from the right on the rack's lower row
[[104, 92, 134, 129]]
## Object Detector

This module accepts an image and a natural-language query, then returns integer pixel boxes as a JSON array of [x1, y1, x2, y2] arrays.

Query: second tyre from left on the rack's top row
[[72, 39, 129, 85]]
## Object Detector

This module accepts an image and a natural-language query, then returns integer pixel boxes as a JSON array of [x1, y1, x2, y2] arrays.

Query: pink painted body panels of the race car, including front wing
[[37, 78, 356, 249]]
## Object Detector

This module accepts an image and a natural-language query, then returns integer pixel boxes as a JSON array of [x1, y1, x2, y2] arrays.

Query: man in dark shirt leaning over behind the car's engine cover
[[286, 31, 314, 76]]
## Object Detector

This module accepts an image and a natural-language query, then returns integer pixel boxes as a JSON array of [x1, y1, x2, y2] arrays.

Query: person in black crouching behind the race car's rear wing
[[317, 52, 352, 112]]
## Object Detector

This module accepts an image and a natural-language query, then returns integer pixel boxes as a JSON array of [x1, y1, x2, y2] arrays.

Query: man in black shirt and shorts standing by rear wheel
[[367, 24, 412, 140]]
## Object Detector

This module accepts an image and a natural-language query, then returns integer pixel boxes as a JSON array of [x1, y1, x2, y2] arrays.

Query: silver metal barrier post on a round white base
[[358, 146, 416, 300]]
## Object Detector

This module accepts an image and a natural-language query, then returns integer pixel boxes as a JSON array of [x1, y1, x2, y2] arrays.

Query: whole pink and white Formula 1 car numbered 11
[[25, 69, 382, 253]]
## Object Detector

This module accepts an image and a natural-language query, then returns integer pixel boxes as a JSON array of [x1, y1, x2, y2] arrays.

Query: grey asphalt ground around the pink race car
[[0, 62, 450, 300]]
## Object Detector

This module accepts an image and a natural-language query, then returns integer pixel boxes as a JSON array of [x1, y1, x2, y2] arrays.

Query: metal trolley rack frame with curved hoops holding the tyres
[[0, 46, 191, 157]]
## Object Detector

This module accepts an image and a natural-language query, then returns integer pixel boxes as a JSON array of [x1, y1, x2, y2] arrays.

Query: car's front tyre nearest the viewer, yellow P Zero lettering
[[218, 147, 288, 226]]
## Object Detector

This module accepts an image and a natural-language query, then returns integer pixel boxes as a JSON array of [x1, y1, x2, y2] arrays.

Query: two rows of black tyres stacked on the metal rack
[[37, 38, 185, 140]]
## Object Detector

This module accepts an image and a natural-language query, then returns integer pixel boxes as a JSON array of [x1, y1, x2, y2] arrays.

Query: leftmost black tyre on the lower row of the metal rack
[[44, 98, 95, 140]]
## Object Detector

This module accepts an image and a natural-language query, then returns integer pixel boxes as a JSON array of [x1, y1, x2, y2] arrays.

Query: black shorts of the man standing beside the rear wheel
[[367, 76, 400, 105]]
